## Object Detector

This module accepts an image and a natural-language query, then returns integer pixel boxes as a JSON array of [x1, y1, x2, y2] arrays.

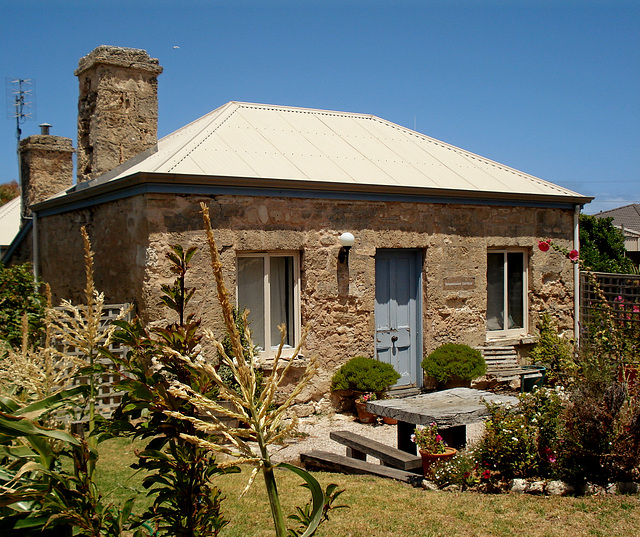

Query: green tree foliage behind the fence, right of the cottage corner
[[580, 214, 636, 274]]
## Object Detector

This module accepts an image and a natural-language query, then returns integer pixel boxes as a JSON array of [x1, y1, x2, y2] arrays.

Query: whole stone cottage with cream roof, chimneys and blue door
[[5, 46, 590, 398]]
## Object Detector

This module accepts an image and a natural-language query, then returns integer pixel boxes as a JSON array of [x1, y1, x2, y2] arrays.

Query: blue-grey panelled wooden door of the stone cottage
[[375, 249, 422, 387]]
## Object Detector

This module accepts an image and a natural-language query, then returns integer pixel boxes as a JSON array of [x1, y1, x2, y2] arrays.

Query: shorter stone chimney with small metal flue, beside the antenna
[[20, 131, 74, 226]]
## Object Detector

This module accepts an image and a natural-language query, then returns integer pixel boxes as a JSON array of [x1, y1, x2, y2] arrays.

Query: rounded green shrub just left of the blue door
[[331, 356, 400, 392]]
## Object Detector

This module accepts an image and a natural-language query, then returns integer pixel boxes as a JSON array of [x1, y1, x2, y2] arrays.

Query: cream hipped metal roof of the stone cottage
[[78, 102, 589, 202]]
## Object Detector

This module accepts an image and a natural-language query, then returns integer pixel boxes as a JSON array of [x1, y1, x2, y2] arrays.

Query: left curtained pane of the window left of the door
[[238, 257, 265, 349]]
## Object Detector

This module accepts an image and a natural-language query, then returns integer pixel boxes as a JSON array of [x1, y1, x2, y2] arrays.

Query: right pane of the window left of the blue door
[[269, 256, 294, 347]]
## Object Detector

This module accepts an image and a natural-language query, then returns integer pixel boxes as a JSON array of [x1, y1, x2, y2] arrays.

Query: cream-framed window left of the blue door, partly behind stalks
[[237, 252, 300, 355]]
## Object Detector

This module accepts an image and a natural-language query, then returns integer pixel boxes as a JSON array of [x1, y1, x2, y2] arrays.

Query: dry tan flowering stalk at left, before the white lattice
[[46, 226, 130, 433]]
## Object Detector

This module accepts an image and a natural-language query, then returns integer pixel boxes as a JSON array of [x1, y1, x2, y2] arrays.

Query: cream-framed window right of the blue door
[[487, 250, 529, 337]]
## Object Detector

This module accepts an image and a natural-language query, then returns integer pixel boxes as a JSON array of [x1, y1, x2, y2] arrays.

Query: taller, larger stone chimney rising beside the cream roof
[[75, 45, 162, 181]]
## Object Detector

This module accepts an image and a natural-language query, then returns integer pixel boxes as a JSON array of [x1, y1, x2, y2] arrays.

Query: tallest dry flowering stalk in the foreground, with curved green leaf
[[166, 203, 324, 537]]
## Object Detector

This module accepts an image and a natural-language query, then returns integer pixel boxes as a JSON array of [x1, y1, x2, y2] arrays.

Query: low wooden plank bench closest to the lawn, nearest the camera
[[300, 450, 424, 486]]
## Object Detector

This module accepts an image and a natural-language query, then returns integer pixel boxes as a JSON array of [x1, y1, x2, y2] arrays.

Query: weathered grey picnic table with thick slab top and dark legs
[[367, 388, 518, 454]]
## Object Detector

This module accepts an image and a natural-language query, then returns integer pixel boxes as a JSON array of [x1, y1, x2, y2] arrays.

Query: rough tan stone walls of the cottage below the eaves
[[37, 194, 573, 398]]
